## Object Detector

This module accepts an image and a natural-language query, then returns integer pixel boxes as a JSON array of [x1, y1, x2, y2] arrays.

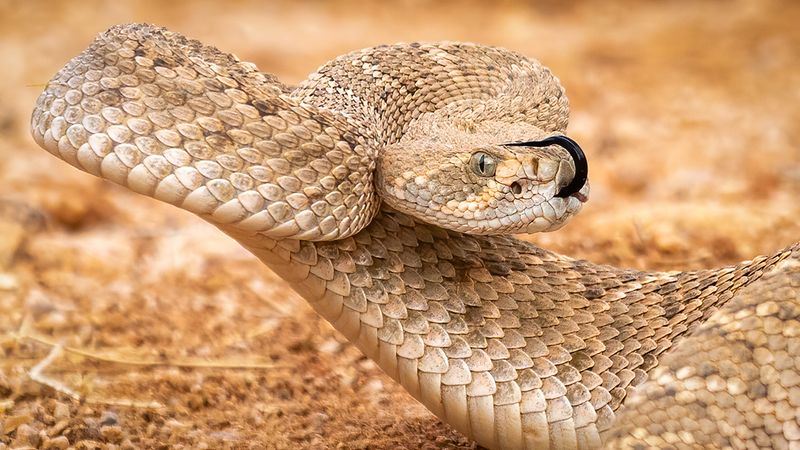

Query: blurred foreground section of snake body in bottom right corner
[[607, 250, 800, 449]]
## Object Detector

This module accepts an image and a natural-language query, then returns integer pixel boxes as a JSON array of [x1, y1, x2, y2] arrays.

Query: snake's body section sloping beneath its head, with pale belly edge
[[223, 211, 789, 447]]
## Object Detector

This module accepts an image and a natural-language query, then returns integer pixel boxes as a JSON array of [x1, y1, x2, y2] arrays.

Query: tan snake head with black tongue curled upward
[[377, 121, 589, 235]]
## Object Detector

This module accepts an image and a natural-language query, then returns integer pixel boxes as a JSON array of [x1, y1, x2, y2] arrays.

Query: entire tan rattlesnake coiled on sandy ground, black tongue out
[[32, 24, 800, 448]]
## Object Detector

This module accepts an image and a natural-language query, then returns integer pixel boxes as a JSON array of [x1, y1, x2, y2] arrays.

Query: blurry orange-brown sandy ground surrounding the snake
[[0, 0, 800, 449]]
